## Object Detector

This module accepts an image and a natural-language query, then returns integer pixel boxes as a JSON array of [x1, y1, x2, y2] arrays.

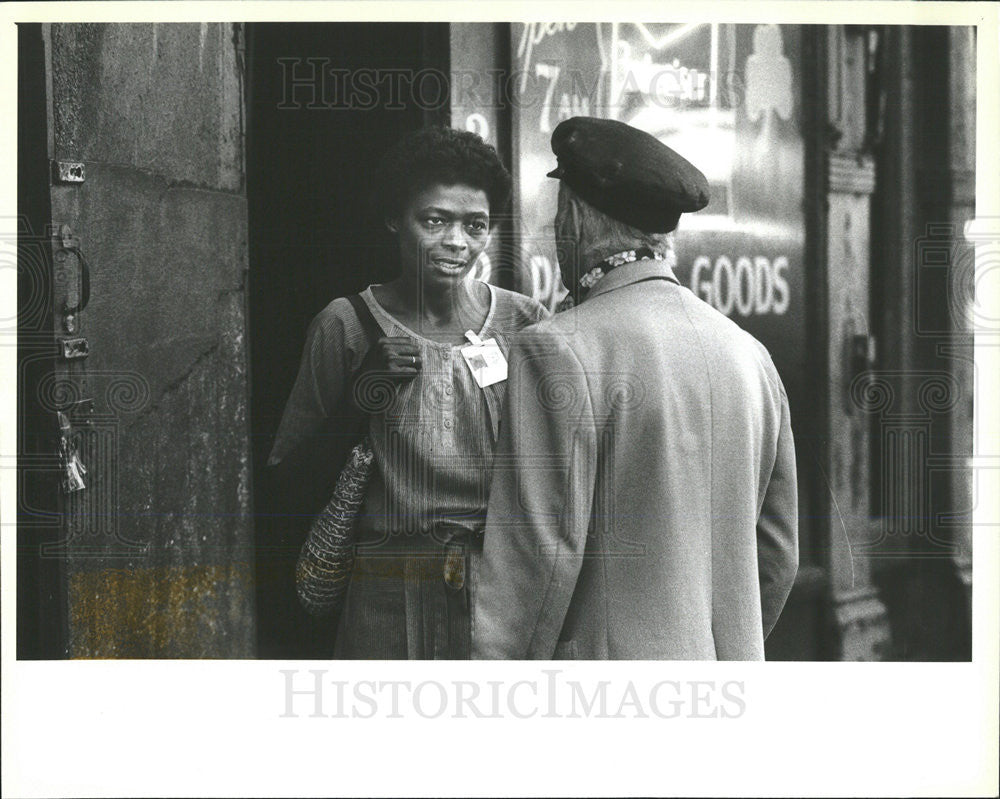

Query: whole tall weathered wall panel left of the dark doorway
[[51, 24, 255, 657]]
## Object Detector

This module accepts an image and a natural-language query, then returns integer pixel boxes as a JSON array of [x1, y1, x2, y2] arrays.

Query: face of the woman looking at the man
[[388, 184, 490, 291]]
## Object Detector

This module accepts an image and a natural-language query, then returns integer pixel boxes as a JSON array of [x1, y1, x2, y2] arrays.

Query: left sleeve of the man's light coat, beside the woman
[[472, 334, 597, 659]]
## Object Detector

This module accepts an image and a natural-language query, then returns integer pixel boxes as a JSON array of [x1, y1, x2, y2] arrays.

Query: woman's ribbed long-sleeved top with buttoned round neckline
[[269, 284, 548, 551]]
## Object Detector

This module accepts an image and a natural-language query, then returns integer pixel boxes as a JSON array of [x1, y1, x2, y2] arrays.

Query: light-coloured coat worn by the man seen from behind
[[472, 260, 798, 660]]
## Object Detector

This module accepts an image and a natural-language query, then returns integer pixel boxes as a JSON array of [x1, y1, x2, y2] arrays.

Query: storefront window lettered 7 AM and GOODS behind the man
[[511, 23, 805, 392]]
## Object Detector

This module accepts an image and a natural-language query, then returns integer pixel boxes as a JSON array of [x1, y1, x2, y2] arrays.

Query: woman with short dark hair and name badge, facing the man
[[271, 128, 547, 659]]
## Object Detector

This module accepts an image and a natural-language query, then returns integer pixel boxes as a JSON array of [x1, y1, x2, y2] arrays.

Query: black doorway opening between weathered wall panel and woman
[[247, 23, 448, 658]]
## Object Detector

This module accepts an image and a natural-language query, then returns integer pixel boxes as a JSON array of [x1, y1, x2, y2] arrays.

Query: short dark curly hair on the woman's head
[[372, 127, 511, 219]]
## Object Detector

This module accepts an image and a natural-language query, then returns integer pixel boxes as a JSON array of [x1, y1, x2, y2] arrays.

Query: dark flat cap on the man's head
[[548, 117, 708, 233]]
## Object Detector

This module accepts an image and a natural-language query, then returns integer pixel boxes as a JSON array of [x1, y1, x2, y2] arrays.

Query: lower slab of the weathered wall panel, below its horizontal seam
[[53, 165, 253, 657]]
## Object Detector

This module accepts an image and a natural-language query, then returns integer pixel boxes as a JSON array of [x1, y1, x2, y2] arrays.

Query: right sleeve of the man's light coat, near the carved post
[[757, 387, 799, 638]]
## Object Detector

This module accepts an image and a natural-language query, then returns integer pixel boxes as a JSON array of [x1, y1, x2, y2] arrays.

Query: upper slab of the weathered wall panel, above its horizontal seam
[[52, 23, 243, 191]]
